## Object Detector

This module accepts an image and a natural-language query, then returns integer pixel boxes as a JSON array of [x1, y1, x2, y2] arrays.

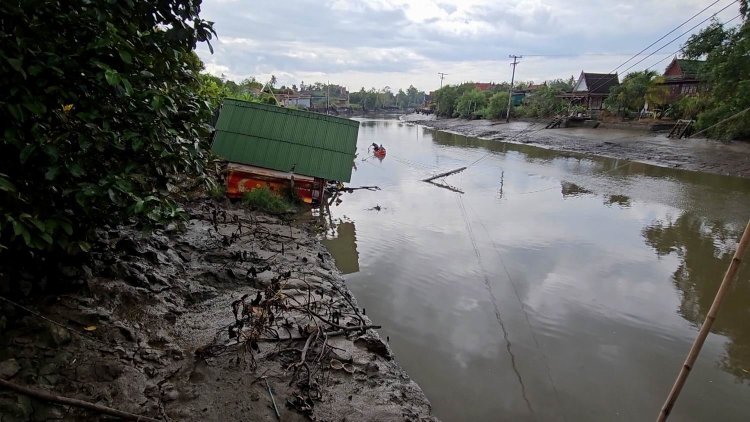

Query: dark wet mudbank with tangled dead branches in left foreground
[[0, 199, 434, 421]]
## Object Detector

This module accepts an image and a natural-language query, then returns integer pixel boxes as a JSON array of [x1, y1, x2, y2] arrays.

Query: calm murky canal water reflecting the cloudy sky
[[325, 120, 750, 422]]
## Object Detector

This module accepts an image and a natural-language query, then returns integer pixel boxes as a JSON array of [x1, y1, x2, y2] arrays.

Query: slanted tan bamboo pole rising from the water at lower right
[[656, 221, 750, 422]]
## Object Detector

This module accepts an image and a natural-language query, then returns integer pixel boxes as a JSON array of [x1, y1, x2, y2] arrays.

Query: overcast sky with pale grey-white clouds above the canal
[[198, 0, 739, 91]]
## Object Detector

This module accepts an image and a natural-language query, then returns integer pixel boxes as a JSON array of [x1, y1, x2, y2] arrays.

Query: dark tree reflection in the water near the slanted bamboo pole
[[643, 212, 750, 380]]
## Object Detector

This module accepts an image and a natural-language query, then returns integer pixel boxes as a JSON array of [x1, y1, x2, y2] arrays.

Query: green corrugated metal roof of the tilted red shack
[[212, 99, 359, 182]]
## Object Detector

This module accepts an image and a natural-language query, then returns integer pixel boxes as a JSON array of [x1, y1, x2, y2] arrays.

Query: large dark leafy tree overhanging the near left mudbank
[[0, 0, 213, 267]]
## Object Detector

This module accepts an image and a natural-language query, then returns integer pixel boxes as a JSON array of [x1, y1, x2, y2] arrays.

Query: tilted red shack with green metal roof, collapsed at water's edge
[[211, 99, 359, 203]]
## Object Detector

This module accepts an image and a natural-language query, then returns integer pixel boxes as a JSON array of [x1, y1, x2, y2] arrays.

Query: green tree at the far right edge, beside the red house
[[683, 10, 750, 139]]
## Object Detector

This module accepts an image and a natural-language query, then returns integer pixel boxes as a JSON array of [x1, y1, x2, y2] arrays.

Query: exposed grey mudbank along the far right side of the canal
[[402, 115, 750, 178]]
